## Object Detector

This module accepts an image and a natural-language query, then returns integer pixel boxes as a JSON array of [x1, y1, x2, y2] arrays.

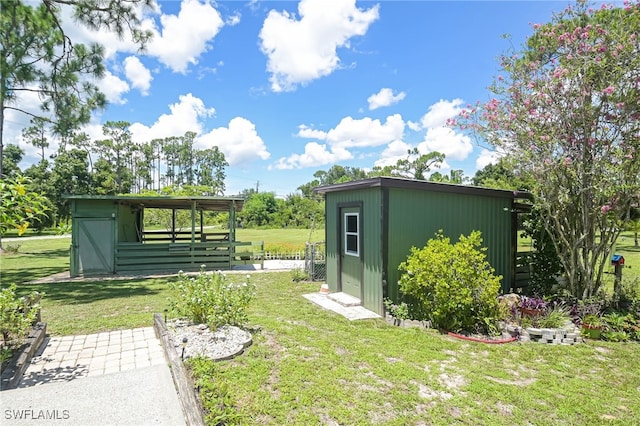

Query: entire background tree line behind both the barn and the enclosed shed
[[3, 135, 475, 229]]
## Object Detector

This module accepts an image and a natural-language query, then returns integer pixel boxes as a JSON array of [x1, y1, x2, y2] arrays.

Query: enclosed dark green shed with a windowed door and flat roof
[[315, 177, 532, 315]]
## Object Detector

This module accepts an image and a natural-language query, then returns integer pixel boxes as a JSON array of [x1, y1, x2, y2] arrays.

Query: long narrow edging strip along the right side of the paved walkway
[[153, 314, 204, 426]]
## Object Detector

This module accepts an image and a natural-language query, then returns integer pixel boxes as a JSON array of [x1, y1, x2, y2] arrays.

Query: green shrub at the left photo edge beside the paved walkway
[[0, 284, 41, 347]]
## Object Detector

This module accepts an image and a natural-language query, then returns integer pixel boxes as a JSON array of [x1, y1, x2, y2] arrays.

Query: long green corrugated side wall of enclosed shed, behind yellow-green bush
[[387, 188, 511, 300]]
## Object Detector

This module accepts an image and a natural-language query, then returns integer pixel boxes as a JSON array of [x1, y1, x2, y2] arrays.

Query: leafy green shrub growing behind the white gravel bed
[[169, 265, 255, 329]]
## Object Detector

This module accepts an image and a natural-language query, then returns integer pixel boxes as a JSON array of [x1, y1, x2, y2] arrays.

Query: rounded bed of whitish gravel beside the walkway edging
[[167, 319, 252, 361]]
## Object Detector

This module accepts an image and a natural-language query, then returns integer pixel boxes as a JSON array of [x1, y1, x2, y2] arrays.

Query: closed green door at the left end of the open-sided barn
[[76, 218, 115, 275]]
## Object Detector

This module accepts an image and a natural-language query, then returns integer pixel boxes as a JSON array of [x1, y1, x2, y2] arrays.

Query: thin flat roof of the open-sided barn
[[64, 195, 245, 211]]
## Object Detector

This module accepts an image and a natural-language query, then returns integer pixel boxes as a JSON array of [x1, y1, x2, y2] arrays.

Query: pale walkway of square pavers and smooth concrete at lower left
[[0, 327, 185, 425]]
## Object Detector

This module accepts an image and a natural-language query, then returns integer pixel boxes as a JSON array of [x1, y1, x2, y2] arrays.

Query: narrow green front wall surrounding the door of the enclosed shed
[[325, 188, 383, 314]]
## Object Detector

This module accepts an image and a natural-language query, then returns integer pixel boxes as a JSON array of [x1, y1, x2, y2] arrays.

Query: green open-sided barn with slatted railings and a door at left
[[66, 195, 253, 277]]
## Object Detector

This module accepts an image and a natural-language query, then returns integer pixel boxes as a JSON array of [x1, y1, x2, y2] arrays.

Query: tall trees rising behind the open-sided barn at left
[[3, 118, 228, 227]]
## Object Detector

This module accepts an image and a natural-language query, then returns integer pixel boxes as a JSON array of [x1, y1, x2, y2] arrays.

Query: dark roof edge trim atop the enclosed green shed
[[314, 176, 533, 200]]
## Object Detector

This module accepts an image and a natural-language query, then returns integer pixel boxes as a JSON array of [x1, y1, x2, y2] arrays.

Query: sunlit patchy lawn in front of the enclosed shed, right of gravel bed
[[191, 274, 640, 425]]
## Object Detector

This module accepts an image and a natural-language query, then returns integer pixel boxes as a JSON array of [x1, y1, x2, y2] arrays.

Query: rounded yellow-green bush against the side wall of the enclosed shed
[[399, 231, 502, 334]]
